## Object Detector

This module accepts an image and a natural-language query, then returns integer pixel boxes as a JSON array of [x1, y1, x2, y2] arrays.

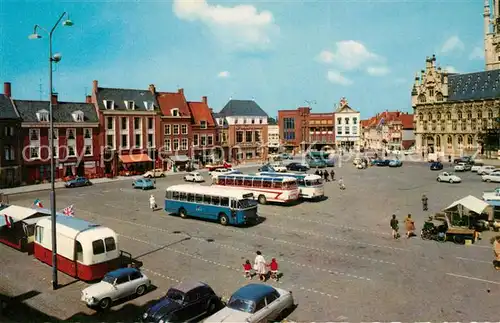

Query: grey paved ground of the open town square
[[0, 163, 500, 321]]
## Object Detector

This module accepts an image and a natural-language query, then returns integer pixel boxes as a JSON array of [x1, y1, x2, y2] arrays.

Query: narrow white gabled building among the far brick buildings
[[335, 98, 361, 150]]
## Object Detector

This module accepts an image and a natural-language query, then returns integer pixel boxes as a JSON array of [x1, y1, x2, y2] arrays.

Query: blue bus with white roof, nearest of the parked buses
[[165, 184, 258, 225]]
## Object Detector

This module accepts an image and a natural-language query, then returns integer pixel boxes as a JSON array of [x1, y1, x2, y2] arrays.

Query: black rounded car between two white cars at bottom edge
[[141, 282, 221, 323]]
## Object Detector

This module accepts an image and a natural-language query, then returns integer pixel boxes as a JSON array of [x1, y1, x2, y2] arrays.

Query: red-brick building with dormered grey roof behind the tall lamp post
[[14, 94, 102, 184]]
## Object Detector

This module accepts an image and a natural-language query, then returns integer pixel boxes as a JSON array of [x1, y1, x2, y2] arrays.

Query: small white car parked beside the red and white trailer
[[81, 268, 151, 310]]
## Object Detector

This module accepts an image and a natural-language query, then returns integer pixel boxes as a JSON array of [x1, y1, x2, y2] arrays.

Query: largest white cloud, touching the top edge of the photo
[[173, 0, 279, 50]]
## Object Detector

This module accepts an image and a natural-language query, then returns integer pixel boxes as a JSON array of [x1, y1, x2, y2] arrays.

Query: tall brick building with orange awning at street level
[[89, 81, 160, 176]]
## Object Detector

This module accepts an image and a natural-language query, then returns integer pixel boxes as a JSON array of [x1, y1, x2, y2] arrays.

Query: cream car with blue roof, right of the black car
[[205, 284, 294, 323]]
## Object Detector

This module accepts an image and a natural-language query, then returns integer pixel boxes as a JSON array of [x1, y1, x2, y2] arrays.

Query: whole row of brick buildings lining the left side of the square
[[0, 81, 267, 187]]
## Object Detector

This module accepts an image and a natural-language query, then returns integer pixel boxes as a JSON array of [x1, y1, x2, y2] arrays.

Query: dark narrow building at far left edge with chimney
[[0, 82, 22, 188]]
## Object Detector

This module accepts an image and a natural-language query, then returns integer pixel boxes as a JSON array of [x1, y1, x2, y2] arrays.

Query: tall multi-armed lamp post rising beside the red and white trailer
[[28, 12, 73, 290]]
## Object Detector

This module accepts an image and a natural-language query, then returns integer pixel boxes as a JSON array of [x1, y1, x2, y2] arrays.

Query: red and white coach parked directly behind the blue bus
[[213, 174, 299, 204]]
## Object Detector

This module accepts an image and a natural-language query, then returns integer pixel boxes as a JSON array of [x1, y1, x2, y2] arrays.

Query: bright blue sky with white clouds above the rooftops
[[0, 0, 484, 118]]
